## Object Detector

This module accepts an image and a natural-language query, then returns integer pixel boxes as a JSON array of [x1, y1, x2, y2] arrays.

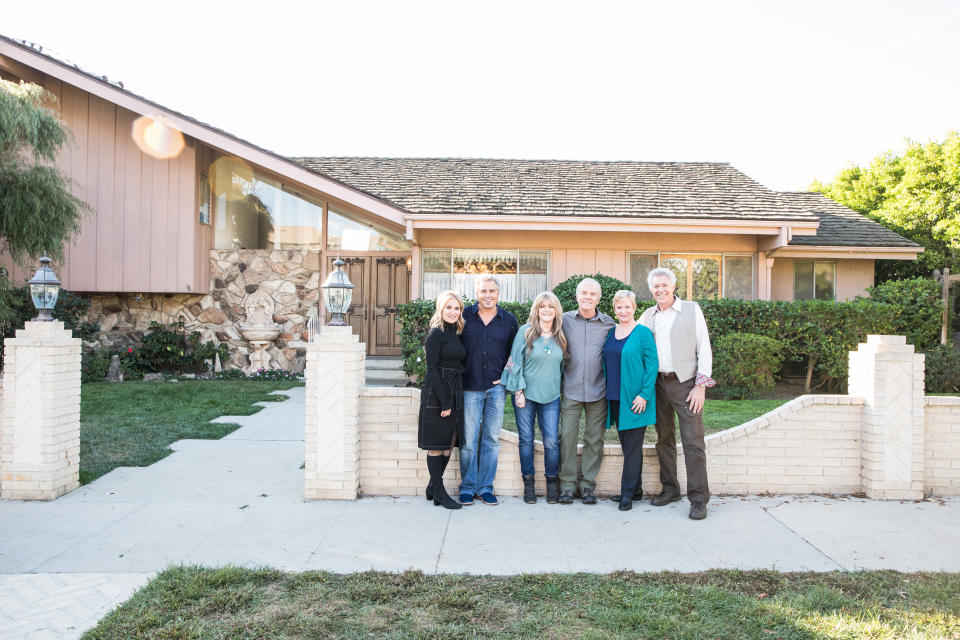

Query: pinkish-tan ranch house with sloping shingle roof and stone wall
[[0, 37, 922, 369]]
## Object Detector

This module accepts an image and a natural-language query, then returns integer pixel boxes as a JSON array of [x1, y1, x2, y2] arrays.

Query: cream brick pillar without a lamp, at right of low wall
[[849, 336, 924, 500]]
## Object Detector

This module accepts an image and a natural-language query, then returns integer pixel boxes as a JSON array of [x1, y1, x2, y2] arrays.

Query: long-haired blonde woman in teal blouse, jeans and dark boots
[[501, 291, 567, 504]]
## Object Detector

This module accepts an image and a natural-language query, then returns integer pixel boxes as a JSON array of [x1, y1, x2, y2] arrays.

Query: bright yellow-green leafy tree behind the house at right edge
[[810, 131, 960, 282]]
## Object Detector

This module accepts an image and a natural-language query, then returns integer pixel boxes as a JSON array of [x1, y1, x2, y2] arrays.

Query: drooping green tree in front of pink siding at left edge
[[0, 80, 90, 262]]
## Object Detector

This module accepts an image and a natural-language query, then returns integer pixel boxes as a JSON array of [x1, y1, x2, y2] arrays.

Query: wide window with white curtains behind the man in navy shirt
[[420, 249, 549, 302]]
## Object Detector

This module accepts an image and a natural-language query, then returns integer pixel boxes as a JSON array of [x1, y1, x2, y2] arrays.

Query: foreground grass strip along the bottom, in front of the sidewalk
[[83, 567, 960, 640]]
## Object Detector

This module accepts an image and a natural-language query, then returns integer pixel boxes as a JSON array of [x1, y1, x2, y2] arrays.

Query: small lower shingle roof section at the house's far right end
[[778, 191, 920, 247]]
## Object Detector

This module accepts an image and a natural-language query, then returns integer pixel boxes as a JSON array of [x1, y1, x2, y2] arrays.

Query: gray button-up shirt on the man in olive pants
[[563, 311, 616, 402]]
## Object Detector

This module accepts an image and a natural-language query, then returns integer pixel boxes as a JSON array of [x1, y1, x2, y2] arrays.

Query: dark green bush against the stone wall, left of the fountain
[[120, 320, 229, 375]]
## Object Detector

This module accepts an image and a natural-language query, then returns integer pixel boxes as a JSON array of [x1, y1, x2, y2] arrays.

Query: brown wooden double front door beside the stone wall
[[327, 255, 410, 356]]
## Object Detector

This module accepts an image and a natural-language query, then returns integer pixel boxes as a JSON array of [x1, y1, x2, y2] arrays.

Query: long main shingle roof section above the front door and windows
[[293, 158, 815, 221]]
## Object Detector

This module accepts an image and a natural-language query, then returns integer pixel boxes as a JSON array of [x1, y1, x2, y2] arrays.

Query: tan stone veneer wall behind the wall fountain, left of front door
[[86, 249, 320, 373]]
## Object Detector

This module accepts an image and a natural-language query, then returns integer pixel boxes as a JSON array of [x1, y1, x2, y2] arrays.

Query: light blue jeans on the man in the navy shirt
[[460, 384, 506, 496]]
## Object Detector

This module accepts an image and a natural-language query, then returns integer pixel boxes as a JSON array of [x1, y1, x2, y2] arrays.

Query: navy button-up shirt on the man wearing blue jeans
[[460, 304, 518, 391]]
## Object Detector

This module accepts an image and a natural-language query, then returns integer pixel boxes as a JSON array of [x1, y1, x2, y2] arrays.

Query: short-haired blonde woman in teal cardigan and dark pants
[[603, 289, 659, 511]]
